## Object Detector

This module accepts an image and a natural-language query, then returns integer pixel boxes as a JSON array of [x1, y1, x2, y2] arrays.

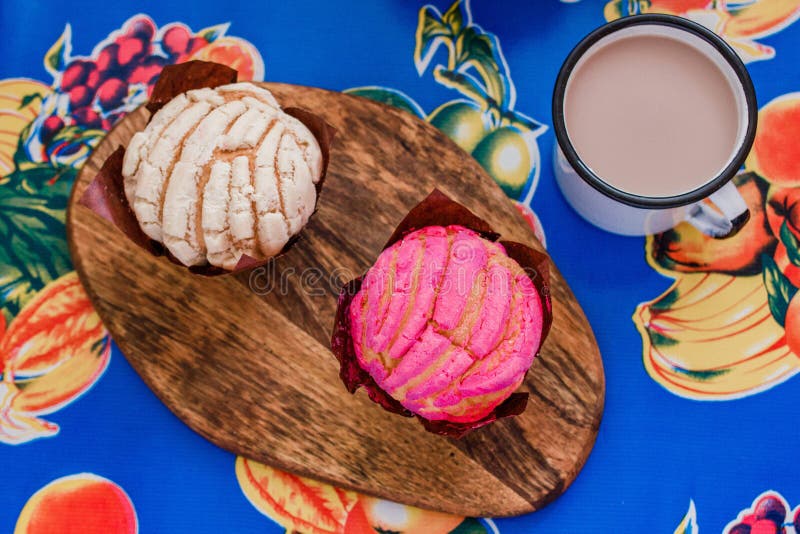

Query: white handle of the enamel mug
[[684, 182, 750, 239]]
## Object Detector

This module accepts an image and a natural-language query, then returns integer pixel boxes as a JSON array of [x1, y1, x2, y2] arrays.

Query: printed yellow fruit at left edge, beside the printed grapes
[[0, 78, 51, 176]]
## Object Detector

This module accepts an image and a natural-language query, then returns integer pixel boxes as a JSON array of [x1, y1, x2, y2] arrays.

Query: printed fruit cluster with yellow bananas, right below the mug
[[634, 93, 800, 400]]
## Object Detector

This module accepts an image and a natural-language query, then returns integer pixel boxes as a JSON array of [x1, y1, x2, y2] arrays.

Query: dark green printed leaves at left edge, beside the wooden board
[[0, 167, 75, 319]]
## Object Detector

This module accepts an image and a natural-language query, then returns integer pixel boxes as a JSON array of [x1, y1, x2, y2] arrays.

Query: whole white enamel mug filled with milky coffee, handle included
[[553, 15, 757, 237]]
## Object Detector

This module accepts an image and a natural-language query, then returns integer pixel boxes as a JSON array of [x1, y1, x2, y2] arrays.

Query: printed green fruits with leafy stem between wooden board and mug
[[346, 0, 547, 204]]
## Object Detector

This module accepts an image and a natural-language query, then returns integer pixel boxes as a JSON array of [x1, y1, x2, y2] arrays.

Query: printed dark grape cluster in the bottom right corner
[[723, 491, 800, 534]]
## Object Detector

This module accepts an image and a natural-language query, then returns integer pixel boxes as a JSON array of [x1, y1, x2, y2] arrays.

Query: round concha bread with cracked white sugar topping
[[122, 83, 322, 269]]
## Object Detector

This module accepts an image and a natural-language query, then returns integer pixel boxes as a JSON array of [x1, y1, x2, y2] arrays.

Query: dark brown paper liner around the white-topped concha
[[78, 61, 336, 276]]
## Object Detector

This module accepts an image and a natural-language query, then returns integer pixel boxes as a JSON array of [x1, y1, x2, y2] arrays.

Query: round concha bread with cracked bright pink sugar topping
[[349, 226, 545, 423]]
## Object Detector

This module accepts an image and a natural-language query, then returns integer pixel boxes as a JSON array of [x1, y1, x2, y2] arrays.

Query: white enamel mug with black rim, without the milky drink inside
[[553, 14, 758, 238]]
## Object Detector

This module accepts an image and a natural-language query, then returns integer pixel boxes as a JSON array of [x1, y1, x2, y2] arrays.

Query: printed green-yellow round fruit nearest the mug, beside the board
[[472, 126, 533, 198]]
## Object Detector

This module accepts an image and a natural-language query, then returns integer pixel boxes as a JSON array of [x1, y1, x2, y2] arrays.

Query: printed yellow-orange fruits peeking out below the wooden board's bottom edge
[[236, 456, 486, 534]]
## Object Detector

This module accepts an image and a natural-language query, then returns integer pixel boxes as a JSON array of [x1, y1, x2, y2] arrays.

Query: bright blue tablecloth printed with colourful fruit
[[0, 0, 800, 534]]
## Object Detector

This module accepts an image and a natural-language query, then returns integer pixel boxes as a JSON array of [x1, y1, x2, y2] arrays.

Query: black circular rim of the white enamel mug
[[553, 14, 758, 209]]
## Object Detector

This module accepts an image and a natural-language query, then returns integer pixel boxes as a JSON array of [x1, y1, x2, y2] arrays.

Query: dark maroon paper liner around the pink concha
[[331, 189, 553, 439]]
